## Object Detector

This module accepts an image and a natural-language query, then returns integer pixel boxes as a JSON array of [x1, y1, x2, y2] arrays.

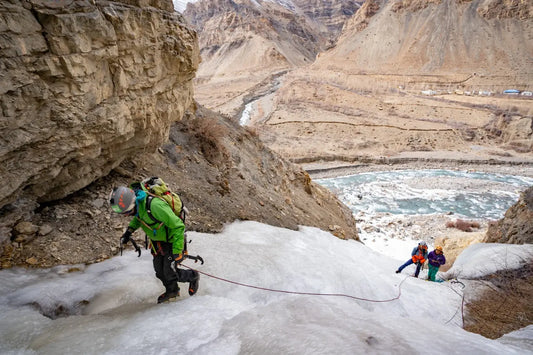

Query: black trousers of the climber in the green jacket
[[151, 242, 194, 294]]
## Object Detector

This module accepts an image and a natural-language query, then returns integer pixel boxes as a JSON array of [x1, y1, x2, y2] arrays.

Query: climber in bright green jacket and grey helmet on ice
[[109, 186, 200, 303]]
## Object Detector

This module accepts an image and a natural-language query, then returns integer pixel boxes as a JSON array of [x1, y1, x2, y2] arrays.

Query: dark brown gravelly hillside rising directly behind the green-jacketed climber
[[1, 108, 358, 267]]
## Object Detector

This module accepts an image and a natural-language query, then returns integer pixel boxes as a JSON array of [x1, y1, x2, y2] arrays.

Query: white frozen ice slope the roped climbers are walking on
[[0, 222, 533, 355]]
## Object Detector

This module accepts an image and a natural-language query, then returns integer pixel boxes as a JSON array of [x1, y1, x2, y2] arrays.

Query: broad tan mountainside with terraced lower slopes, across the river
[[242, 0, 533, 166]]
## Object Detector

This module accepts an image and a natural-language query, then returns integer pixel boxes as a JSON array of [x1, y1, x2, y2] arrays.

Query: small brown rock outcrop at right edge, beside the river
[[485, 186, 533, 244]]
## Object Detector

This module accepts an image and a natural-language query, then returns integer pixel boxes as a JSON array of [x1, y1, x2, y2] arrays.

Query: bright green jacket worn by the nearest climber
[[129, 191, 185, 254]]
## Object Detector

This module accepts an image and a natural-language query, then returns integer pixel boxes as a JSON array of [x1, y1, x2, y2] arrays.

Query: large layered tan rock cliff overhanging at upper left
[[0, 0, 199, 240]]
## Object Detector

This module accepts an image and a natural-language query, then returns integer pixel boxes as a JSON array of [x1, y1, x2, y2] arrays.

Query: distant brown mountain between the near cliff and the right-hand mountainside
[[184, 0, 358, 115]]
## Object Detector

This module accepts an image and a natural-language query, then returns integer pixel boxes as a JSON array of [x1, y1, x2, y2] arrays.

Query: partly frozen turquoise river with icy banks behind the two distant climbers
[[315, 169, 533, 255]]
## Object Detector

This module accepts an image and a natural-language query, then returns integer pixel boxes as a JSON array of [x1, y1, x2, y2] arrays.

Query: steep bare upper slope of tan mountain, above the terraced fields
[[316, 0, 533, 81]]
